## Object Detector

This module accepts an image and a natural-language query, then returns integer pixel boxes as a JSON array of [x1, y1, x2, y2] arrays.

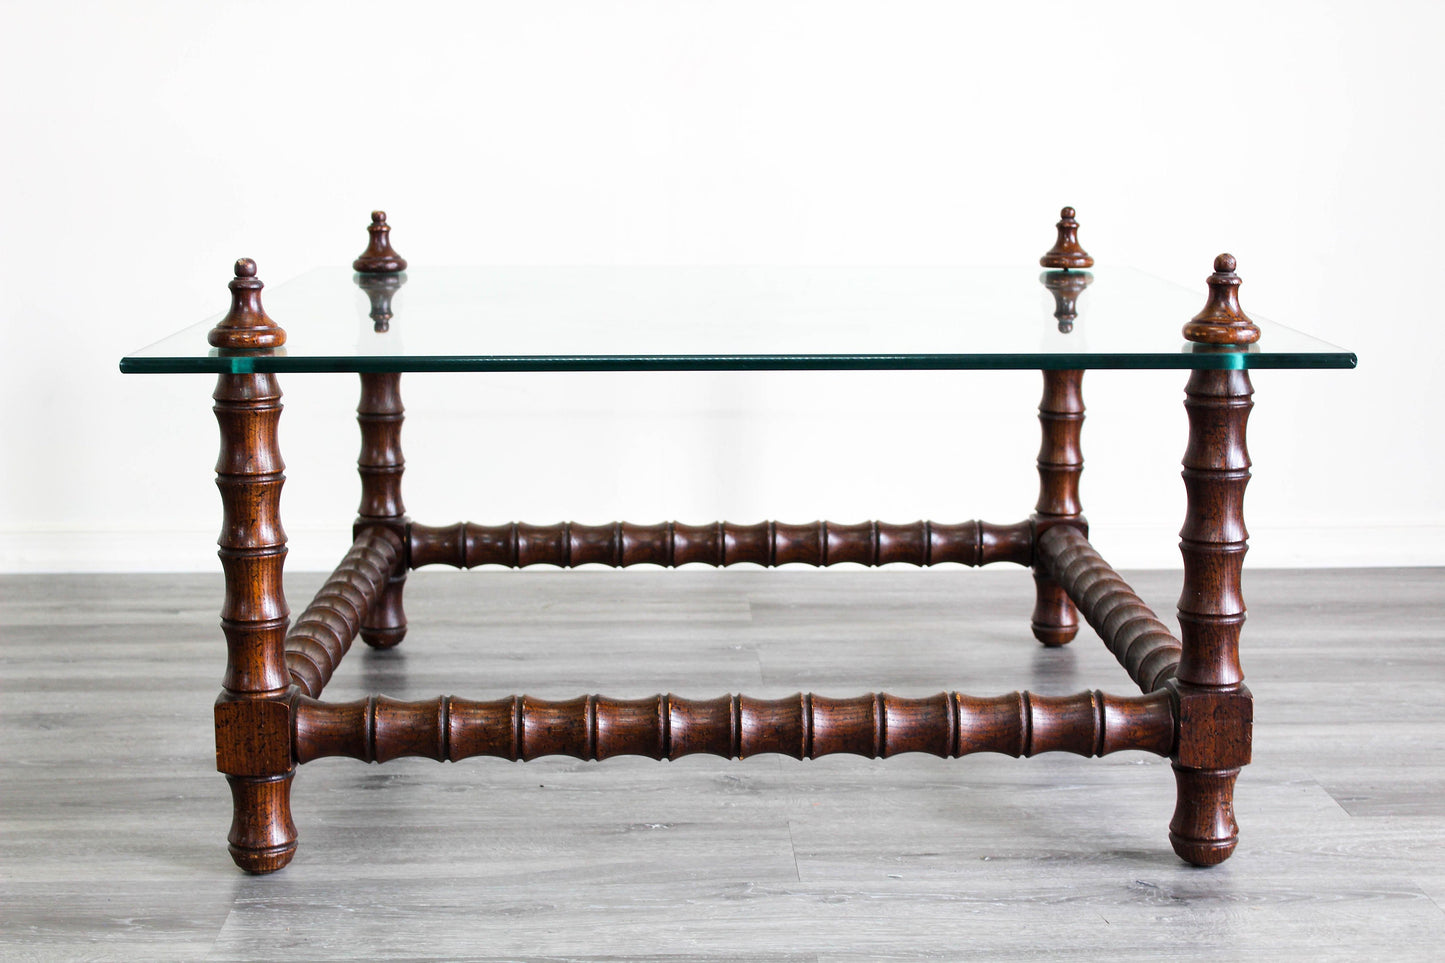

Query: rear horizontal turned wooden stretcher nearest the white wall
[[409, 522, 1033, 568]]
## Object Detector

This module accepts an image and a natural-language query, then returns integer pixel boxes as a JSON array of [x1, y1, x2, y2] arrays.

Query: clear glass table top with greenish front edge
[[120, 268, 1355, 373]]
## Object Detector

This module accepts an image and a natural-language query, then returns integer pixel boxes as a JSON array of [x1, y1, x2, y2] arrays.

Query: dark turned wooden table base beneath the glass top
[[206, 370, 1251, 873]]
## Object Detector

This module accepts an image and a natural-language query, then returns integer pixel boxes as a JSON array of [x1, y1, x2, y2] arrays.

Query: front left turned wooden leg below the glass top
[[214, 367, 296, 873]]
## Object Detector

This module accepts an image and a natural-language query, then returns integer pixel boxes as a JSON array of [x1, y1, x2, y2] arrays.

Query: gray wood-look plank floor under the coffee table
[[0, 570, 1445, 962]]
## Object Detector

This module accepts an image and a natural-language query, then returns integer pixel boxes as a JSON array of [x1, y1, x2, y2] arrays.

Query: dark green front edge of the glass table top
[[120, 346, 1358, 375]]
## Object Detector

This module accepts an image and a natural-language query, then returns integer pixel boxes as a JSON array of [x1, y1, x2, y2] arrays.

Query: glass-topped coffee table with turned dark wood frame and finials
[[120, 208, 1355, 873]]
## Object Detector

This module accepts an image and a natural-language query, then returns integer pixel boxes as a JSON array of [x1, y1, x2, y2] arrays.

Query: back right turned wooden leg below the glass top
[[1032, 372, 1085, 645]]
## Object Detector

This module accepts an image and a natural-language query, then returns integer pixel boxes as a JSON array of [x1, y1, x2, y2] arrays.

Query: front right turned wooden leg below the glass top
[[1169, 370, 1254, 866]]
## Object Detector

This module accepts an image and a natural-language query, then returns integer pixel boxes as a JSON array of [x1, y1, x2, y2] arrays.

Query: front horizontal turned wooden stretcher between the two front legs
[[296, 691, 1173, 762]]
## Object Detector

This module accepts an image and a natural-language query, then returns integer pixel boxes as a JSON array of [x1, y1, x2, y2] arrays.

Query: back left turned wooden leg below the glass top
[[355, 372, 409, 649]]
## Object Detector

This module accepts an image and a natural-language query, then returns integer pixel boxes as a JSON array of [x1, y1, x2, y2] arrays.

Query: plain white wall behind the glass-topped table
[[0, 0, 1445, 571]]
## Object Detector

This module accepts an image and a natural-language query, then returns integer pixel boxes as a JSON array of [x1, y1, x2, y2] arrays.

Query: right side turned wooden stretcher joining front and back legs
[[1039, 525, 1181, 693]]
